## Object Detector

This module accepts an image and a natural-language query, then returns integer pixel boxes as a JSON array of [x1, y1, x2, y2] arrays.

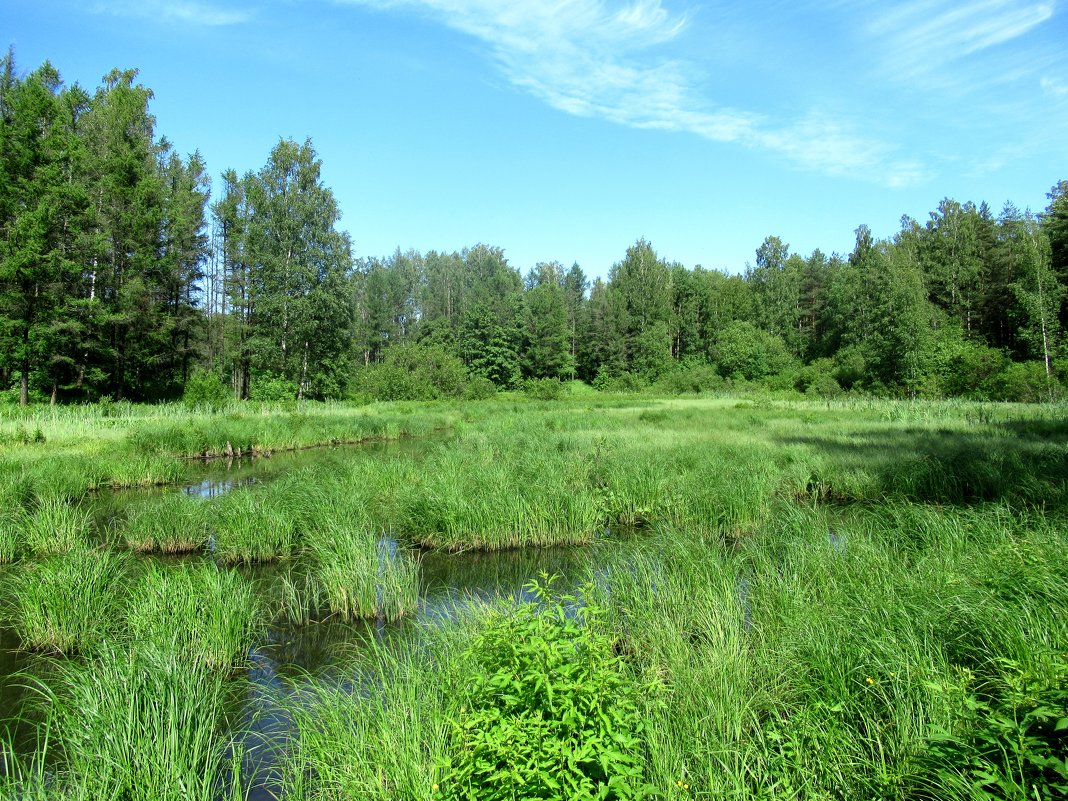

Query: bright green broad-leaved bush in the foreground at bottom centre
[[437, 579, 653, 801]]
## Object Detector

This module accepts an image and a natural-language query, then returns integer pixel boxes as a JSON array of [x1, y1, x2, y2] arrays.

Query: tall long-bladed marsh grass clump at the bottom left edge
[[29, 647, 241, 801]]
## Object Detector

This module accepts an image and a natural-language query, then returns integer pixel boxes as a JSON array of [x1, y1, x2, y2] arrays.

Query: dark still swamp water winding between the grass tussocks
[[0, 440, 619, 801]]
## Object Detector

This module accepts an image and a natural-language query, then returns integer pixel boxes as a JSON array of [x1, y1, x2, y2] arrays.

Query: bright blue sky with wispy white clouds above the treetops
[[0, 0, 1068, 277]]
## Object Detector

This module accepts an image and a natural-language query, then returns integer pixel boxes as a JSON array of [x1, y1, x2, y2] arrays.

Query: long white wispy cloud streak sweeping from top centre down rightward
[[340, 0, 923, 186]]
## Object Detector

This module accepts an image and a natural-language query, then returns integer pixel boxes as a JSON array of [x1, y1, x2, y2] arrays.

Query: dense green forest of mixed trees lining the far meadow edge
[[0, 52, 1068, 404]]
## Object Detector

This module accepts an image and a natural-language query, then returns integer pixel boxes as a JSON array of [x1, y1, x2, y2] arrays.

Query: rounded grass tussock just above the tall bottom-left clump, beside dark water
[[127, 561, 265, 673]]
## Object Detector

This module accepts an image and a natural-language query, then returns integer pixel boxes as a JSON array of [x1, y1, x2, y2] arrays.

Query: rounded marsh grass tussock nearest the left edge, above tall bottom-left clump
[[3, 547, 130, 654]]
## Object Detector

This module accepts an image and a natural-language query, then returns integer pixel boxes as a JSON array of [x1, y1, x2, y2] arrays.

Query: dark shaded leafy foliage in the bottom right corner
[[909, 655, 1068, 801]]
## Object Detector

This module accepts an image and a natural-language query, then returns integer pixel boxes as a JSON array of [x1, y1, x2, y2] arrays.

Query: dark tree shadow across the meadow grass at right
[[780, 420, 1068, 509]]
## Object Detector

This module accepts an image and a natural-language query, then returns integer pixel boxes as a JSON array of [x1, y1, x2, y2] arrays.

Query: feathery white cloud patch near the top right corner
[[867, 0, 1053, 79]]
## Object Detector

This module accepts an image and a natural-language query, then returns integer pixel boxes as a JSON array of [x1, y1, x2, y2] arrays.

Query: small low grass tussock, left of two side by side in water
[[122, 492, 209, 554]]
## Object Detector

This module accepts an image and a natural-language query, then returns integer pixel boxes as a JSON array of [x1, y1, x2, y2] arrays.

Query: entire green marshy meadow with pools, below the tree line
[[0, 390, 1068, 801]]
